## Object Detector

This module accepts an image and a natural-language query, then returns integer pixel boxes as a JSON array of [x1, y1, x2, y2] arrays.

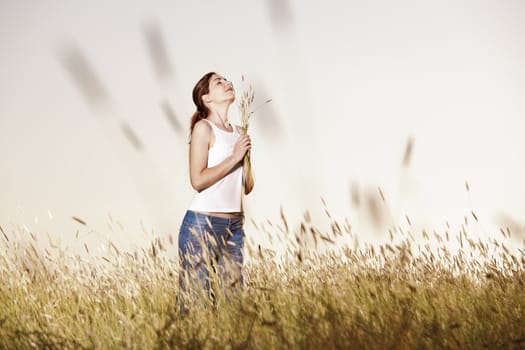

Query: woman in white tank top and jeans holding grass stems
[[179, 72, 253, 296]]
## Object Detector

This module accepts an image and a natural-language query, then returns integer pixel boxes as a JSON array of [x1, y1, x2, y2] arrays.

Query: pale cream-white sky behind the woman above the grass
[[0, 0, 525, 253]]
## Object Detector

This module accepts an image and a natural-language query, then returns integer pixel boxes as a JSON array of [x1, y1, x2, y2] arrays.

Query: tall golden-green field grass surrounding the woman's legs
[[0, 217, 525, 349]]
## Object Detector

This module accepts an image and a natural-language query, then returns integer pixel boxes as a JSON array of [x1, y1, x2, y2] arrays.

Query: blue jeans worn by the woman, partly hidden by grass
[[179, 210, 244, 296]]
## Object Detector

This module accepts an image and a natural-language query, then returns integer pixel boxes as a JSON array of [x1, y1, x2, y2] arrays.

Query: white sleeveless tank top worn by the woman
[[189, 119, 243, 213]]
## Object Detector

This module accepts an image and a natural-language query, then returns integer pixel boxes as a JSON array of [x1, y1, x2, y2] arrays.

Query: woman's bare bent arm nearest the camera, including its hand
[[190, 121, 251, 192]]
